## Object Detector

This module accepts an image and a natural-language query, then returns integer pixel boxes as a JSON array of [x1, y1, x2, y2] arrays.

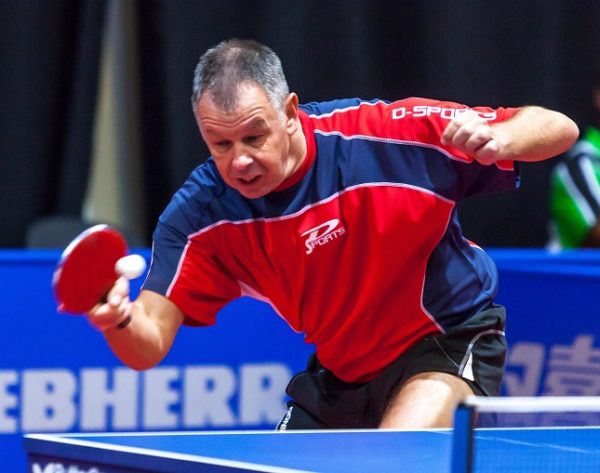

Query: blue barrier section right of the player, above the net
[[489, 250, 600, 426]]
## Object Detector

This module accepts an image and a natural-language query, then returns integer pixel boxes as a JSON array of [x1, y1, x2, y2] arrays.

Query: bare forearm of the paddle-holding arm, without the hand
[[103, 292, 183, 370]]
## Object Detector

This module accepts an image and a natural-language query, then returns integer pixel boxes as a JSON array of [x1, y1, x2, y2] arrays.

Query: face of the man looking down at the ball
[[196, 84, 296, 199]]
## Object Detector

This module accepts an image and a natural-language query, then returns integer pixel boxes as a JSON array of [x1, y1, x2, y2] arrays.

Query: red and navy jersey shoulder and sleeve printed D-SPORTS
[[300, 97, 519, 201]]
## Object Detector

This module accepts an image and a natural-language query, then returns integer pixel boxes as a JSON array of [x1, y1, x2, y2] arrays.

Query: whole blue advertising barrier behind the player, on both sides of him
[[0, 250, 600, 472]]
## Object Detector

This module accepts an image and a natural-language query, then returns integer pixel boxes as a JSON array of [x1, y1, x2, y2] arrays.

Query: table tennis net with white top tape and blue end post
[[452, 397, 600, 473]]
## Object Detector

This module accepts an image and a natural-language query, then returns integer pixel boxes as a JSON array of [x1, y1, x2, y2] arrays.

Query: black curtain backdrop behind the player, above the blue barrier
[[0, 0, 600, 247]]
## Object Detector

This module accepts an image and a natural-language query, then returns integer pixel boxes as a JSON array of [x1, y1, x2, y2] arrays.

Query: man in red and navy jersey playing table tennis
[[88, 40, 578, 429]]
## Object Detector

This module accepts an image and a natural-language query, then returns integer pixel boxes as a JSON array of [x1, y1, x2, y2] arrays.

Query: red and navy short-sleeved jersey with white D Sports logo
[[144, 98, 518, 382]]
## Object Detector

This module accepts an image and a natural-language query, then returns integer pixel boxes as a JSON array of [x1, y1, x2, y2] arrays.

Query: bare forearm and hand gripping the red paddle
[[88, 278, 184, 370]]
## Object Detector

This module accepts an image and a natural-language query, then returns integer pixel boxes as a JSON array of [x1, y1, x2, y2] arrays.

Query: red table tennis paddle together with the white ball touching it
[[52, 225, 146, 314]]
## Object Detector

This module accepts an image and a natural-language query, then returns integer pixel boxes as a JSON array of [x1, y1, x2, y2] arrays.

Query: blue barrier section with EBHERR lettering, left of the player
[[0, 251, 313, 472]]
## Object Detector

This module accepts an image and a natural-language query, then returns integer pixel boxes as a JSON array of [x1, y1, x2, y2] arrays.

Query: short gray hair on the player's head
[[192, 39, 289, 111]]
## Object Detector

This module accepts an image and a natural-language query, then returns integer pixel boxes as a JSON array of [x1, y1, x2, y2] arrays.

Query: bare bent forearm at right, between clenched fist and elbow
[[492, 106, 579, 162]]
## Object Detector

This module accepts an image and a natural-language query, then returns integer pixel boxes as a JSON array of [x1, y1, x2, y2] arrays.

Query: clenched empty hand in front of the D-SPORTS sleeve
[[441, 110, 501, 165]]
